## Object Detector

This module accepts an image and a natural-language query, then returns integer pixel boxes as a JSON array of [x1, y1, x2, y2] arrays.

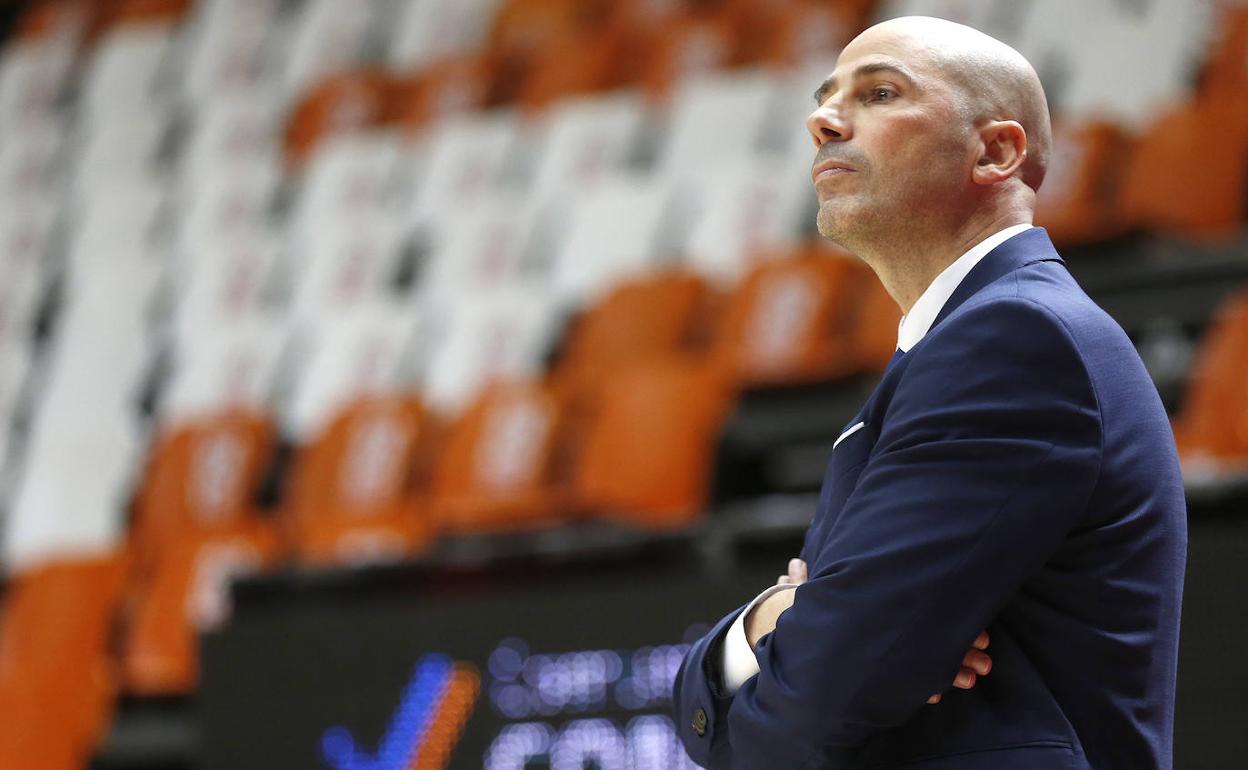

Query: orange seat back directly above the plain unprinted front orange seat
[[559, 271, 714, 387]]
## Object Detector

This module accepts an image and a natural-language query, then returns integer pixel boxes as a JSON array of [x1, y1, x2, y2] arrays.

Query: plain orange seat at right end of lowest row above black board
[[573, 356, 730, 529]]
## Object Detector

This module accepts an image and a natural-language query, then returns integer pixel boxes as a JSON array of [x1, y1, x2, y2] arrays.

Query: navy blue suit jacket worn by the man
[[675, 228, 1187, 770]]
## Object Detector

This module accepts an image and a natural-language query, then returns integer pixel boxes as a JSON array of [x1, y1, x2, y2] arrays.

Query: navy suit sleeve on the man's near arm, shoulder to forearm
[[723, 300, 1101, 770]]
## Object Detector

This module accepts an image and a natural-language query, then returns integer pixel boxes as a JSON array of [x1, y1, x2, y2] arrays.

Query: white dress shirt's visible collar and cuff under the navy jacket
[[721, 225, 1032, 694]]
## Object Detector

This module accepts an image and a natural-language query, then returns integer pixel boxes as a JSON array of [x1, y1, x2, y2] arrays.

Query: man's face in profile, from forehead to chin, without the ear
[[806, 30, 976, 243]]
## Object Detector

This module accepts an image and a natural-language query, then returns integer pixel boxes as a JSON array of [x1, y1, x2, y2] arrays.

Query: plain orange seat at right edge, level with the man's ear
[[1121, 96, 1248, 237]]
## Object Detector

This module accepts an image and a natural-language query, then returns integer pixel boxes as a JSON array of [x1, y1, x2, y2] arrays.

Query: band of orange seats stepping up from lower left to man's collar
[[127, 239, 899, 693]]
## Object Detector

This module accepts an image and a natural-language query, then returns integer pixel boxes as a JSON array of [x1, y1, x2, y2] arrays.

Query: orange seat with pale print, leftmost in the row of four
[[131, 411, 276, 575]]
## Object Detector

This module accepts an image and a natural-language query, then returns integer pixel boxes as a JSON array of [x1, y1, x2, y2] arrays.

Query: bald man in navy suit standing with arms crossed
[[674, 17, 1187, 770]]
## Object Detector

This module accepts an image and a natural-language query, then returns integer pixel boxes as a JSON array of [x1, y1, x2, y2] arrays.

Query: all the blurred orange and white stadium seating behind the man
[[0, 0, 1248, 769]]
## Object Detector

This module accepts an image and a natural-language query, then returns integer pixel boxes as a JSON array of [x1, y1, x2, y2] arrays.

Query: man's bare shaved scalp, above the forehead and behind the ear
[[842, 16, 1052, 190]]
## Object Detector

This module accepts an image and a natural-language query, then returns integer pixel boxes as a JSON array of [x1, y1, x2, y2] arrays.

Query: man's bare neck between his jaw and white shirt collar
[[860, 211, 1031, 313]]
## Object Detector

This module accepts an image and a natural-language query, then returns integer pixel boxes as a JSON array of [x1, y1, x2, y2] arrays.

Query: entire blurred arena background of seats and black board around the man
[[0, 0, 1248, 770]]
